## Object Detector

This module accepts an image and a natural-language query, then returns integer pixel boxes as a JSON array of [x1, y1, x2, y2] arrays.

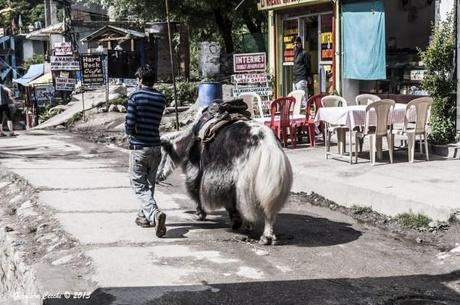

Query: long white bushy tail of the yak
[[236, 124, 292, 222]]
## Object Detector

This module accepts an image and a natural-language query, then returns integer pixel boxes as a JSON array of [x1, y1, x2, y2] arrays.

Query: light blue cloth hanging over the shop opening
[[342, 0, 386, 80]]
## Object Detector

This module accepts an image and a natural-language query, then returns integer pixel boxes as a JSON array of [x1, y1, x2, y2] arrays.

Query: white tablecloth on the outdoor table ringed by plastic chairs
[[315, 104, 416, 129]]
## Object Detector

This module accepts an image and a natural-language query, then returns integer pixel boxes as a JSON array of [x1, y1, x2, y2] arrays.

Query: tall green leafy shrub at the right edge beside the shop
[[420, 14, 457, 144]]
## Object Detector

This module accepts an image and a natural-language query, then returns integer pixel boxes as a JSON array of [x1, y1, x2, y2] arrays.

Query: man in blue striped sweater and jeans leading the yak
[[125, 65, 166, 237]]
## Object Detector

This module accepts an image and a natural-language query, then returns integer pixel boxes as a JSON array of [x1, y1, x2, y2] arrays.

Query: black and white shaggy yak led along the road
[[157, 101, 292, 244]]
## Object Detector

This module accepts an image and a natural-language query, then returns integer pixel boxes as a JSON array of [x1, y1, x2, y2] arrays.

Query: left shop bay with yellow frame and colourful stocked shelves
[[259, 0, 336, 96]]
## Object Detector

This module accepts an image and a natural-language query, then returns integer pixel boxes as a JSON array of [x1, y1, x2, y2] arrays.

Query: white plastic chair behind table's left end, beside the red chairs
[[321, 95, 351, 157]]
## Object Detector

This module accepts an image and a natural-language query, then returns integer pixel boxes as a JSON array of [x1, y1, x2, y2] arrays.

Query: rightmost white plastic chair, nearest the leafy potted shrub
[[393, 97, 433, 162]]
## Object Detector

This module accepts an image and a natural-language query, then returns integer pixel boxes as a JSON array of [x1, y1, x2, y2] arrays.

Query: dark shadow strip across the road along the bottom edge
[[44, 271, 460, 305]]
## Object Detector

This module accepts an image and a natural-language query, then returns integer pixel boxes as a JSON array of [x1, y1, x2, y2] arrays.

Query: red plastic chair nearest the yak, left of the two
[[269, 97, 297, 148]]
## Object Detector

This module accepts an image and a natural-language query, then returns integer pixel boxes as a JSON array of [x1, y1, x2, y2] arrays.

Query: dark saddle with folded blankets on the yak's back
[[195, 99, 251, 144]]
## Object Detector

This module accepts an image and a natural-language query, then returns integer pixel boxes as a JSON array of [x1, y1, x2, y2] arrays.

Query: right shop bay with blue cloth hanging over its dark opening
[[340, 0, 436, 103]]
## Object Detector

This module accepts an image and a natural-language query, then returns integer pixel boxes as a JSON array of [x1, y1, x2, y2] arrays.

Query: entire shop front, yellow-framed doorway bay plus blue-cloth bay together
[[259, 0, 450, 103]]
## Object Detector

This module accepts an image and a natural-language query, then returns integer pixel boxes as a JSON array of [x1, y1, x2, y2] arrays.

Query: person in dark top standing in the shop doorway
[[293, 37, 311, 100]]
